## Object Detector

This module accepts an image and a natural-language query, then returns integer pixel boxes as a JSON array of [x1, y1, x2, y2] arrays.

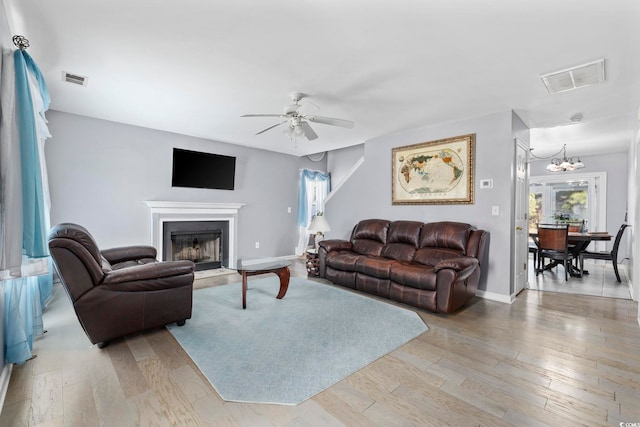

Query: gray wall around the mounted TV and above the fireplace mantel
[[45, 111, 326, 258]]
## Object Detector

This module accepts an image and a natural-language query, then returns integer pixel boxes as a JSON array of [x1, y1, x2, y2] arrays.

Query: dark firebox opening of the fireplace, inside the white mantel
[[162, 221, 229, 271]]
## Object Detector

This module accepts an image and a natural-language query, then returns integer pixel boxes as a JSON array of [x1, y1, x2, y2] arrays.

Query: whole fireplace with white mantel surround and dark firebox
[[144, 200, 244, 270]]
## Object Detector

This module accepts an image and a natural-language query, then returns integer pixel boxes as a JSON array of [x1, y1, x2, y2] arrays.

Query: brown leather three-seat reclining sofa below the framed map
[[318, 219, 487, 313]]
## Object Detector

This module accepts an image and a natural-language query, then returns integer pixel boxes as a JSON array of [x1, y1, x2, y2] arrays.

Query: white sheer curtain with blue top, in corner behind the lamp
[[296, 169, 331, 255]]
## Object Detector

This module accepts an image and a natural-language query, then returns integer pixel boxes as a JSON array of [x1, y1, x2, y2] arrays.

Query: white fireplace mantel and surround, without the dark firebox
[[144, 200, 244, 268]]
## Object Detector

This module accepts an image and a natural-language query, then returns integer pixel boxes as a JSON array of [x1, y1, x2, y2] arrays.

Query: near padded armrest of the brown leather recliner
[[102, 261, 195, 292]]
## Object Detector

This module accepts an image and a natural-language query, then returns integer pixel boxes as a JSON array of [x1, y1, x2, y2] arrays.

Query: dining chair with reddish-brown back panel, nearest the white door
[[536, 224, 574, 282]]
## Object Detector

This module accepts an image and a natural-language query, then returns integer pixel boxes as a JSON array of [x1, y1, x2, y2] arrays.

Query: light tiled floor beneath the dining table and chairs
[[528, 256, 631, 299]]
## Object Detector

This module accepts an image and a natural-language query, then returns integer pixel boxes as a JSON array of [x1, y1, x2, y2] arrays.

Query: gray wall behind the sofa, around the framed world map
[[325, 111, 528, 299]]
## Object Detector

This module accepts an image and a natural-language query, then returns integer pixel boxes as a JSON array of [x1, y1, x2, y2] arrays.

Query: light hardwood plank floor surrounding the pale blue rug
[[0, 262, 640, 427]]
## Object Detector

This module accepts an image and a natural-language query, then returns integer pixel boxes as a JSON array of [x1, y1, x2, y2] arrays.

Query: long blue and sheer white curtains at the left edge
[[0, 50, 53, 363]]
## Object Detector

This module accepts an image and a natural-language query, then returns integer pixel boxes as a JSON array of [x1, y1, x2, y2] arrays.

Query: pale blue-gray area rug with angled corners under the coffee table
[[167, 276, 428, 405]]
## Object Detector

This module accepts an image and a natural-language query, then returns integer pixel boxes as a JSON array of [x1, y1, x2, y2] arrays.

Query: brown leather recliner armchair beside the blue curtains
[[49, 223, 195, 348]]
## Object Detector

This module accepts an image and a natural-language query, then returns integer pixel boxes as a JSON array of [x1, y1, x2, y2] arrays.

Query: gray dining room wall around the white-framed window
[[529, 153, 633, 262]]
